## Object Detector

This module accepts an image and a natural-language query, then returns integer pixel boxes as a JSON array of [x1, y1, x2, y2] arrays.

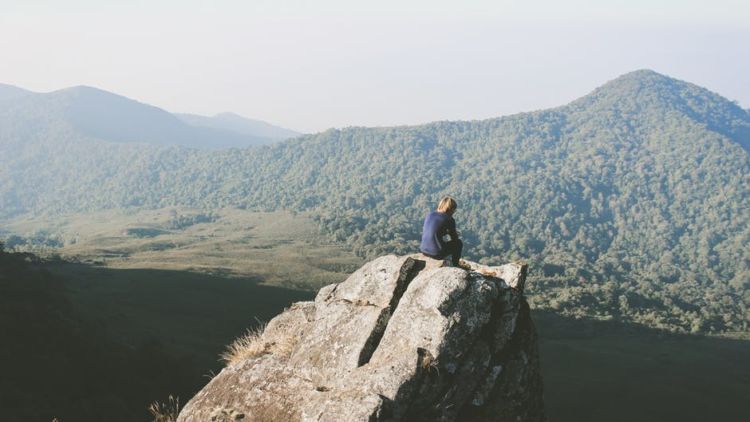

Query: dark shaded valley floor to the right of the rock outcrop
[[534, 312, 750, 422]]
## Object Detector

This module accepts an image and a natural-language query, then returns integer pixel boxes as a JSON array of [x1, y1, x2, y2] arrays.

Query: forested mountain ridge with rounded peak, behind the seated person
[[0, 71, 750, 332]]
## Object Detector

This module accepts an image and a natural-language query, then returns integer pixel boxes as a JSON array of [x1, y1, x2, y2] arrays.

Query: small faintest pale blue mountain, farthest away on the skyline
[[175, 113, 300, 141]]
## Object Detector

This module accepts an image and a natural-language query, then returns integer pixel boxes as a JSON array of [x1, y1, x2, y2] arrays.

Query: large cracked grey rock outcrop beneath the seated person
[[178, 255, 545, 422]]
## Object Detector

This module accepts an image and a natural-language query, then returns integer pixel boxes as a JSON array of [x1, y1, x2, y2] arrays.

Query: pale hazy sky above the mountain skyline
[[0, 0, 750, 132]]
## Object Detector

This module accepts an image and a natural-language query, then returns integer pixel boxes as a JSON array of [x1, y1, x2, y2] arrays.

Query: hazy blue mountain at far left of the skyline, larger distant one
[[0, 86, 284, 149]]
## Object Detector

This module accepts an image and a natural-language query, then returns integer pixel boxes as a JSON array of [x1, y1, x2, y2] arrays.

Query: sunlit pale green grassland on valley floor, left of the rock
[[3, 207, 363, 290]]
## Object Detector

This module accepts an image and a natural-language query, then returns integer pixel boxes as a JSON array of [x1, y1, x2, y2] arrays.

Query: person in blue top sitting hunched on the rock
[[419, 196, 464, 267]]
